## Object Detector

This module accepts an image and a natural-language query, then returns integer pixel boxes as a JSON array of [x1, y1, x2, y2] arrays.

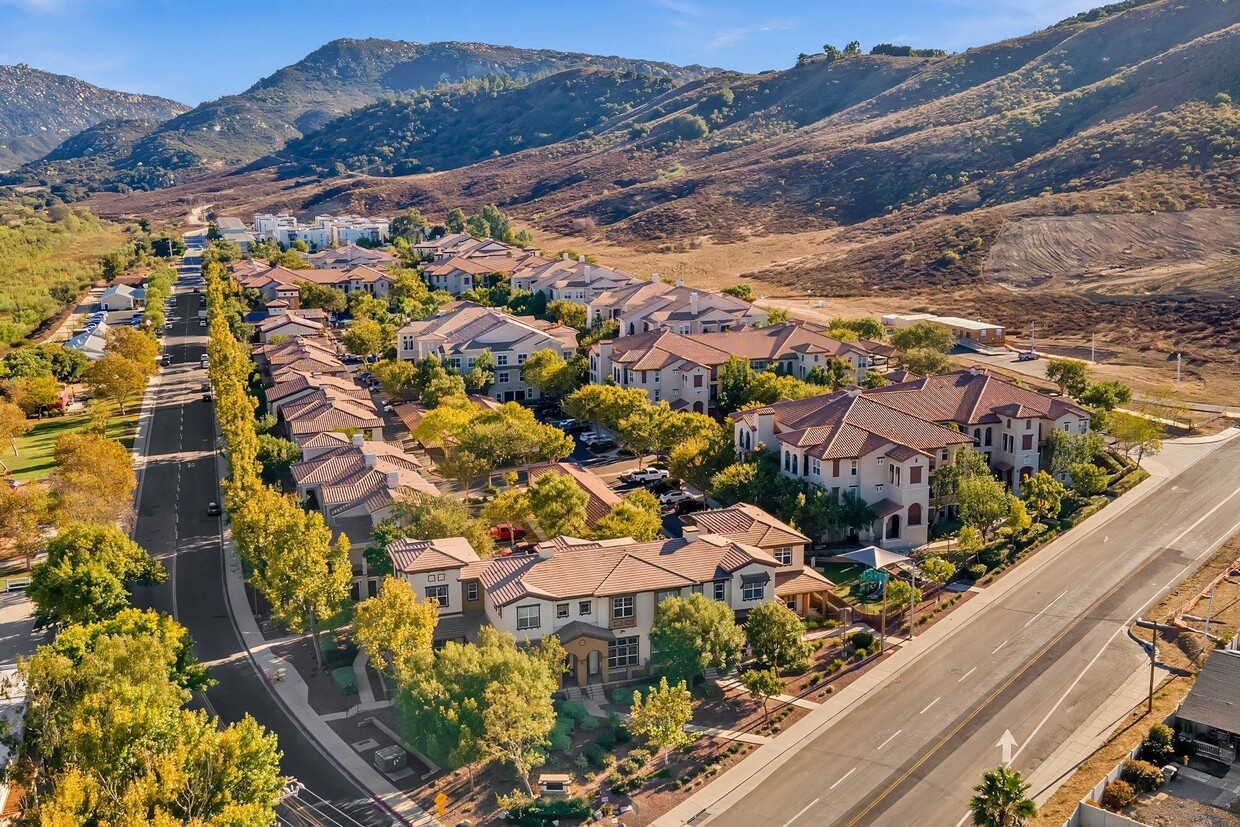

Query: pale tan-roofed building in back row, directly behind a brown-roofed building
[[587, 280, 768, 336]]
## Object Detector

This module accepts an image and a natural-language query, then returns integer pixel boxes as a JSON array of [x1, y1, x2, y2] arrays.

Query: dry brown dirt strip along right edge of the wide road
[[1034, 534, 1240, 827]]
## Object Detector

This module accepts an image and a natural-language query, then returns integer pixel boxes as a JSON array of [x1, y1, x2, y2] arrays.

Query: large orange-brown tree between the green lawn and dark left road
[[51, 431, 138, 524]]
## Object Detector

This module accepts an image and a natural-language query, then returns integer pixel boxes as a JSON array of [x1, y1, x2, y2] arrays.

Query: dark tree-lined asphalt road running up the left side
[[134, 269, 392, 826]]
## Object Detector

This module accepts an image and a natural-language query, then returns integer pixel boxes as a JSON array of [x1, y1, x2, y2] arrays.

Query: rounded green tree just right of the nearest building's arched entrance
[[650, 594, 745, 681]]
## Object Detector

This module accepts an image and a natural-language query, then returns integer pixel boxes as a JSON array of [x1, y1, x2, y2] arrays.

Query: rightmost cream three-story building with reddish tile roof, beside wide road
[[866, 368, 1090, 495]]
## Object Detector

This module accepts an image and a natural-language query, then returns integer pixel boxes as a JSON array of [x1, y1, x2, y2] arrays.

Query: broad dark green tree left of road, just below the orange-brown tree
[[26, 523, 167, 624]]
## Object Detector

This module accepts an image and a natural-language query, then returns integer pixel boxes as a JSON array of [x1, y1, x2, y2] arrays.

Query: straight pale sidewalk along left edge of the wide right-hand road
[[653, 438, 1168, 827]]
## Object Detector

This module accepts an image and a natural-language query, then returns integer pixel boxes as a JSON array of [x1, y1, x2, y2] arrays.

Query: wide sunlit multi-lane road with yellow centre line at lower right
[[694, 439, 1240, 827]]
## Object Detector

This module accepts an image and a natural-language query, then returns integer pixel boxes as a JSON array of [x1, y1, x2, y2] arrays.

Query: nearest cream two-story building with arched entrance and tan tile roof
[[388, 533, 780, 686]]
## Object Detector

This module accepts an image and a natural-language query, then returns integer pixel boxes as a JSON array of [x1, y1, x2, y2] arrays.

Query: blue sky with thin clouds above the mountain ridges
[[0, 0, 1101, 104]]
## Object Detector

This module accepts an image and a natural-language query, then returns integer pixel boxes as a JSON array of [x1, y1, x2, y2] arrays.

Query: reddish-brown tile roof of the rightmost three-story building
[[866, 369, 1089, 425]]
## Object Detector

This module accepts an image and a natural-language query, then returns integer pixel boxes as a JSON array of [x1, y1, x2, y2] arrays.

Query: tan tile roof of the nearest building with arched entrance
[[460, 534, 779, 606]]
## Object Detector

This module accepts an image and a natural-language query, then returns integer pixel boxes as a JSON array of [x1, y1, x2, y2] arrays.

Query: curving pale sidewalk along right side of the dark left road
[[216, 416, 441, 827]]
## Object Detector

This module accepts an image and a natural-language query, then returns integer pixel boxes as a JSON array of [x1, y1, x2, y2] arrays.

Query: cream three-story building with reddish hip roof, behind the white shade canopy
[[732, 388, 973, 549]]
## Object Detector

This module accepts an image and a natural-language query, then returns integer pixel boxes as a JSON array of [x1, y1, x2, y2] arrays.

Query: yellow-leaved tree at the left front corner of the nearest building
[[353, 577, 439, 686]]
